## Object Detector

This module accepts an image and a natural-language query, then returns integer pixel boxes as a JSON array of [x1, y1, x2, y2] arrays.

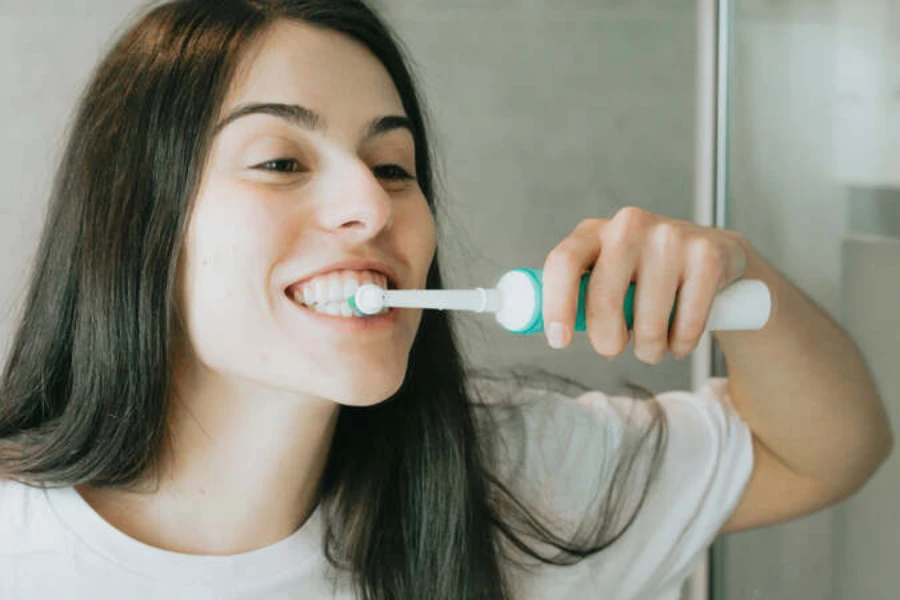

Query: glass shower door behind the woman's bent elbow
[[712, 0, 900, 600]]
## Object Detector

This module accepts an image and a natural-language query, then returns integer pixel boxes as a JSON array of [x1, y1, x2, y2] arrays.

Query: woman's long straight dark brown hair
[[0, 0, 666, 600]]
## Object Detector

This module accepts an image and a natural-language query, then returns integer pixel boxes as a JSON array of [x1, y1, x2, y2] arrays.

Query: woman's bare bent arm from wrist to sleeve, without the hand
[[713, 242, 893, 533]]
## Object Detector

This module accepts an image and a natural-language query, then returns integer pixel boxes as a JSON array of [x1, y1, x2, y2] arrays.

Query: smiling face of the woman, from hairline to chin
[[179, 21, 435, 405]]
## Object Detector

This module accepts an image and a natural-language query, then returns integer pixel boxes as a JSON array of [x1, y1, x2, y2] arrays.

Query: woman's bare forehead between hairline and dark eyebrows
[[221, 20, 405, 121]]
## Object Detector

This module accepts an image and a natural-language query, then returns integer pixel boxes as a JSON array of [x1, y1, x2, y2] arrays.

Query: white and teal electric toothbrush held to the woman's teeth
[[348, 268, 772, 335]]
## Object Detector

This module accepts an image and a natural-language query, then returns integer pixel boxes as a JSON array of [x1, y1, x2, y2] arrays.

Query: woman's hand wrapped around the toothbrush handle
[[543, 206, 747, 365]]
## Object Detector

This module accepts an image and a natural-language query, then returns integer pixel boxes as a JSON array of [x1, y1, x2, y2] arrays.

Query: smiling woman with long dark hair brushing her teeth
[[0, 0, 892, 599]]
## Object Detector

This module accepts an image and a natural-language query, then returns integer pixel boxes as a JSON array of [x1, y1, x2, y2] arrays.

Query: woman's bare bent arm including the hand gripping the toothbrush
[[543, 207, 893, 531]]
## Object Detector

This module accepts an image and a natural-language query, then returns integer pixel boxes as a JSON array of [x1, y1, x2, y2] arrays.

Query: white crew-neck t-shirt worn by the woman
[[0, 378, 753, 600]]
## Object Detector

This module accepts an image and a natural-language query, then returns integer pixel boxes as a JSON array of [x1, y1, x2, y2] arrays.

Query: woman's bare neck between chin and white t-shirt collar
[[78, 364, 340, 555]]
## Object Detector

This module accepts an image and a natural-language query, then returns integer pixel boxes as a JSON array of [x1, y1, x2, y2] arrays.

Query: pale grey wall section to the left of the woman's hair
[[0, 0, 146, 357]]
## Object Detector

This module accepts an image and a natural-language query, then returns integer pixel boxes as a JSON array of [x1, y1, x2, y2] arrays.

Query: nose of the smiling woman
[[321, 160, 394, 238]]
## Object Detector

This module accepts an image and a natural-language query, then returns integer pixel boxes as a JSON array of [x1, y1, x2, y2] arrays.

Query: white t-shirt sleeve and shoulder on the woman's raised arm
[[482, 378, 753, 598]]
